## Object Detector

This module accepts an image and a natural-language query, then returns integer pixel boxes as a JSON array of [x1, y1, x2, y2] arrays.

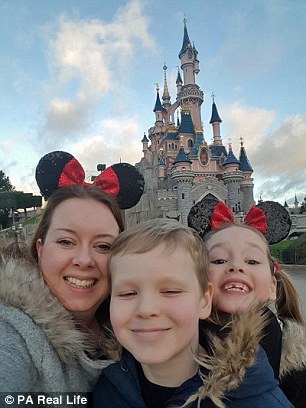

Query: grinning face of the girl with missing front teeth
[[206, 226, 276, 313]]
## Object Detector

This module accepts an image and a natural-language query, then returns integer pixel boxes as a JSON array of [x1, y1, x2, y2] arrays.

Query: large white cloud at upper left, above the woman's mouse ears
[[39, 0, 155, 149]]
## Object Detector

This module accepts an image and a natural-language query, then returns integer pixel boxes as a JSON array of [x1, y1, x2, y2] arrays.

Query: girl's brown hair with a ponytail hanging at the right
[[204, 223, 304, 324]]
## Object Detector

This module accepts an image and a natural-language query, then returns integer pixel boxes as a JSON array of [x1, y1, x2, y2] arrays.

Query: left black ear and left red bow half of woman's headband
[[35, 150, 85, 198]]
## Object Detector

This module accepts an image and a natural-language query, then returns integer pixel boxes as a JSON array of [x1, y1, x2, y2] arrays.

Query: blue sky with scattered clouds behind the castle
[[0, 0, 306, 205]]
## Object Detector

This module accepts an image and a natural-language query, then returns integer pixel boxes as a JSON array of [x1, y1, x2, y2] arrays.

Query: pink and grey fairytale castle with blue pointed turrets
[[126, 21, 255, 225]]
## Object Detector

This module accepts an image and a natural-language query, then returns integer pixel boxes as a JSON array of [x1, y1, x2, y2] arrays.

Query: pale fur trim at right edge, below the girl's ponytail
[[280, 319, 306, 379]]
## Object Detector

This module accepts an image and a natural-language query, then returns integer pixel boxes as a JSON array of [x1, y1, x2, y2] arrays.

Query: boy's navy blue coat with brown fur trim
[[93, 313, 292, 408]]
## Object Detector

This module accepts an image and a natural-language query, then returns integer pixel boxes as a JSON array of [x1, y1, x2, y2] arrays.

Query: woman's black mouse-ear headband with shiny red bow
[[35, 151, 144, 210]]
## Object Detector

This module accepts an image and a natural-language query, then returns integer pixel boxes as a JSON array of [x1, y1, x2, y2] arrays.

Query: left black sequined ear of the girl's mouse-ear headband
[[188, 196, 219, 239]]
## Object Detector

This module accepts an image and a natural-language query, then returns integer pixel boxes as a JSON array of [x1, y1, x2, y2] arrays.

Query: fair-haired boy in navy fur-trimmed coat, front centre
[[93, 219, 291, 408]]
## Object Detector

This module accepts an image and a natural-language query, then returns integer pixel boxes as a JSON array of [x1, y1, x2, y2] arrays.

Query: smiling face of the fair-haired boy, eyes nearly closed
[[110, 244, 212, 380]]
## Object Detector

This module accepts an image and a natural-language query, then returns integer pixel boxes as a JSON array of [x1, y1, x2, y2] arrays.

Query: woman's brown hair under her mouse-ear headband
[[30, 185, 124, 262]]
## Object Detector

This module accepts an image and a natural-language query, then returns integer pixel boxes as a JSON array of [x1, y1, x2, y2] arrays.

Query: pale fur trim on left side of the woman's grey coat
[[0, 256, 86, 364]]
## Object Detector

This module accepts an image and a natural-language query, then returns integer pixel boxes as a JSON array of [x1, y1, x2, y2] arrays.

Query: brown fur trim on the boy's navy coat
[[185, 307, 266, 408]]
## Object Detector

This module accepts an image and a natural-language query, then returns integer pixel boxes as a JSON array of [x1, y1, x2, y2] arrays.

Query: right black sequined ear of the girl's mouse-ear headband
[[256, 201, 292, 245]]
